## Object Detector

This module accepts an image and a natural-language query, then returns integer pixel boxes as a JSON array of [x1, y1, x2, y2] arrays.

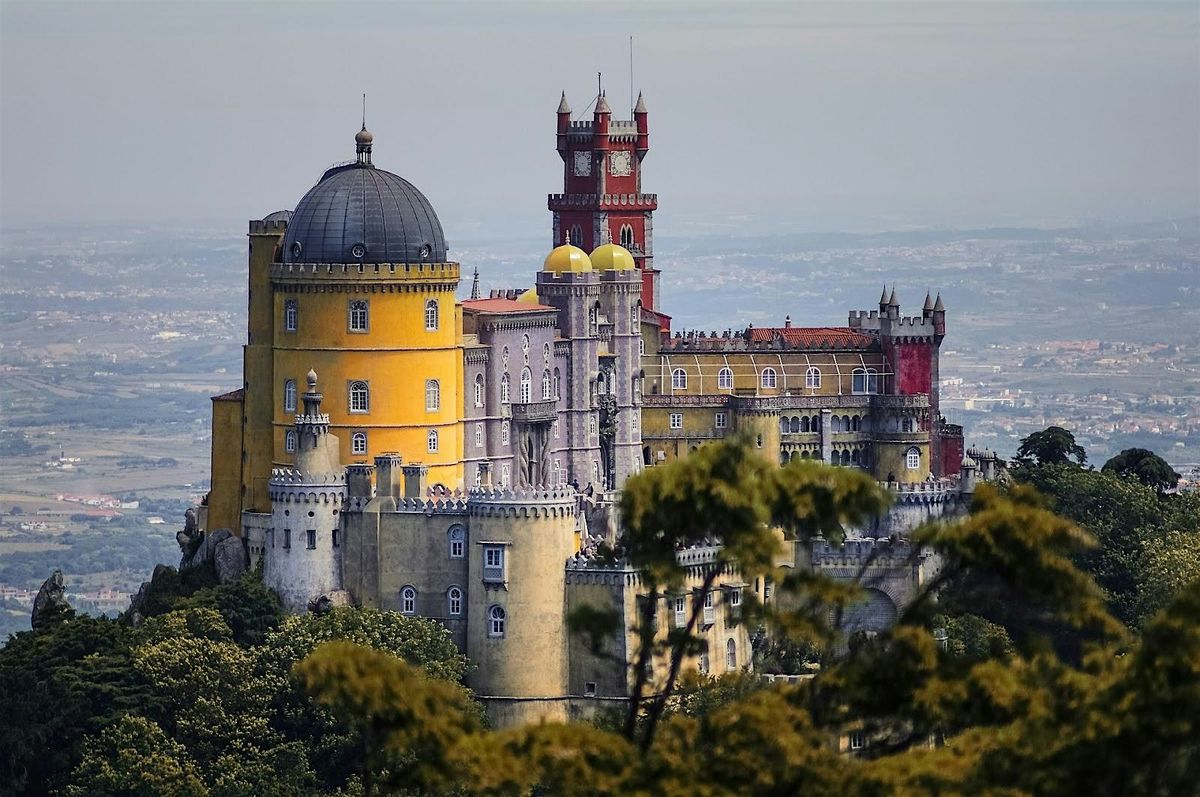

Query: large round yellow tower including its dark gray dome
[[208, 127, 463, 532]]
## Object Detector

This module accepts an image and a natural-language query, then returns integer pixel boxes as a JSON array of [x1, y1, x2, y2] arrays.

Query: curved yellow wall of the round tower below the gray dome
[[271, 263, 463, 489]]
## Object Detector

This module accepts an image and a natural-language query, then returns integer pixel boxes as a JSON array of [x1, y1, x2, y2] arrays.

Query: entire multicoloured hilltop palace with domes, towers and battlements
[[200, 88, 995, 724]]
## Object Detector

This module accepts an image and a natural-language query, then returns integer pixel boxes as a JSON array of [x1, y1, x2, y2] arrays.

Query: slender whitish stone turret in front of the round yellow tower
[[263, 371, 346, 612]]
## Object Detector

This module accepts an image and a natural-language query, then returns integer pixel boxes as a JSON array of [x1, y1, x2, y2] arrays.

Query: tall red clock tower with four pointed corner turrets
[[547, 92, 671, 330]]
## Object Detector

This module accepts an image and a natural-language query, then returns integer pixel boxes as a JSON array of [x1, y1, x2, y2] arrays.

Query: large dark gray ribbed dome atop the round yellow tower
[[283, 162, 446, 263]]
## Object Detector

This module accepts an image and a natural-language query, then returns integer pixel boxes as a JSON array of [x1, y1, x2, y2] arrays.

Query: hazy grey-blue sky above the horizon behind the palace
[[0, 0, 1200, 245]]
